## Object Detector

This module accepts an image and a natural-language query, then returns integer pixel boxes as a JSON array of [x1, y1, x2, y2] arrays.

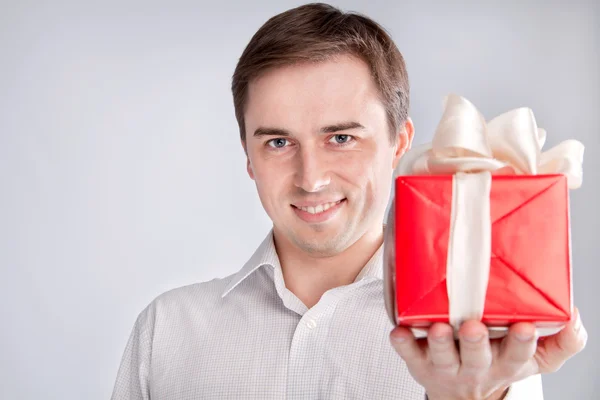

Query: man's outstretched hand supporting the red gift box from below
[[390, 309, 587, 400]]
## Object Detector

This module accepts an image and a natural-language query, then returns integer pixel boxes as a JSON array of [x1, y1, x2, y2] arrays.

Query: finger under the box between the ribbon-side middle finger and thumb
[[495, 322, 537, 376]]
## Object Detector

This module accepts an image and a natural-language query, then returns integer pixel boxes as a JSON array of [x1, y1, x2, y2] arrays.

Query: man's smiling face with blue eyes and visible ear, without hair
[[245, 56, 412, 256]]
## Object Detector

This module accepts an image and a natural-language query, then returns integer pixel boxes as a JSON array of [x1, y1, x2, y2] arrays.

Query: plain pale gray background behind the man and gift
[[0, 0, 600, 400]]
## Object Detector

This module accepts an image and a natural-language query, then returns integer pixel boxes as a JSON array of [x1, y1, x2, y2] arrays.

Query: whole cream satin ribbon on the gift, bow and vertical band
[[394, 94, 584, 333]]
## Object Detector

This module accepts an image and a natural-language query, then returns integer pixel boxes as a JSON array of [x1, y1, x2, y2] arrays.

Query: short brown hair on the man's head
[[231, 3, 409, 142]]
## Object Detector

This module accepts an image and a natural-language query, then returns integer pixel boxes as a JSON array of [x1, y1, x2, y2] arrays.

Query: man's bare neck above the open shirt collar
[[274, 226, 383, 308]]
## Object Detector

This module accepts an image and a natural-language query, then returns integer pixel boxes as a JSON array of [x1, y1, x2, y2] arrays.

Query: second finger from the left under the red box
[[427, 323, 460, 375]]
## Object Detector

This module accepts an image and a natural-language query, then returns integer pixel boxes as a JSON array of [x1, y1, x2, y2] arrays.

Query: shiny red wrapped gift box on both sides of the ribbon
[[390, 174, 572, 328]]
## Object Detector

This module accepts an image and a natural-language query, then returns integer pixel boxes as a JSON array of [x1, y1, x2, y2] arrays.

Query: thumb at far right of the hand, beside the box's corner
[[534, 308, 587, 373]]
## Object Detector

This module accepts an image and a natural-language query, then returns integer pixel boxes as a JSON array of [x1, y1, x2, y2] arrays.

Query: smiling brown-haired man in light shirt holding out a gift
[[112, 4, 586, 400]]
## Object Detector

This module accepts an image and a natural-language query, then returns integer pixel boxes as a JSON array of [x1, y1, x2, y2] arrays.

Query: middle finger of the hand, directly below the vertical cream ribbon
[[458, 321, 492, 380]]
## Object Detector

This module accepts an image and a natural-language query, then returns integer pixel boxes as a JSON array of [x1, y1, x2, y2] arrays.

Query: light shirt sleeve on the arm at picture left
[[111, 306, 153, 400]]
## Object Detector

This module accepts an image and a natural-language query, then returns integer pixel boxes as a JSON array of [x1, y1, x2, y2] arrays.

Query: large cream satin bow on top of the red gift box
[[394, 94, 584, 189]]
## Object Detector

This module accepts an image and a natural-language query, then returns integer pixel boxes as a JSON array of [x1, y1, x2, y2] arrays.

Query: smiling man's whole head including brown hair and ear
[[232, 4, 413, 255]]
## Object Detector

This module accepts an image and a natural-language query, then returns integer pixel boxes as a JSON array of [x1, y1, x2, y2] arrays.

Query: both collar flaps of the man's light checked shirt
[[221, 229, 383, 297]]
